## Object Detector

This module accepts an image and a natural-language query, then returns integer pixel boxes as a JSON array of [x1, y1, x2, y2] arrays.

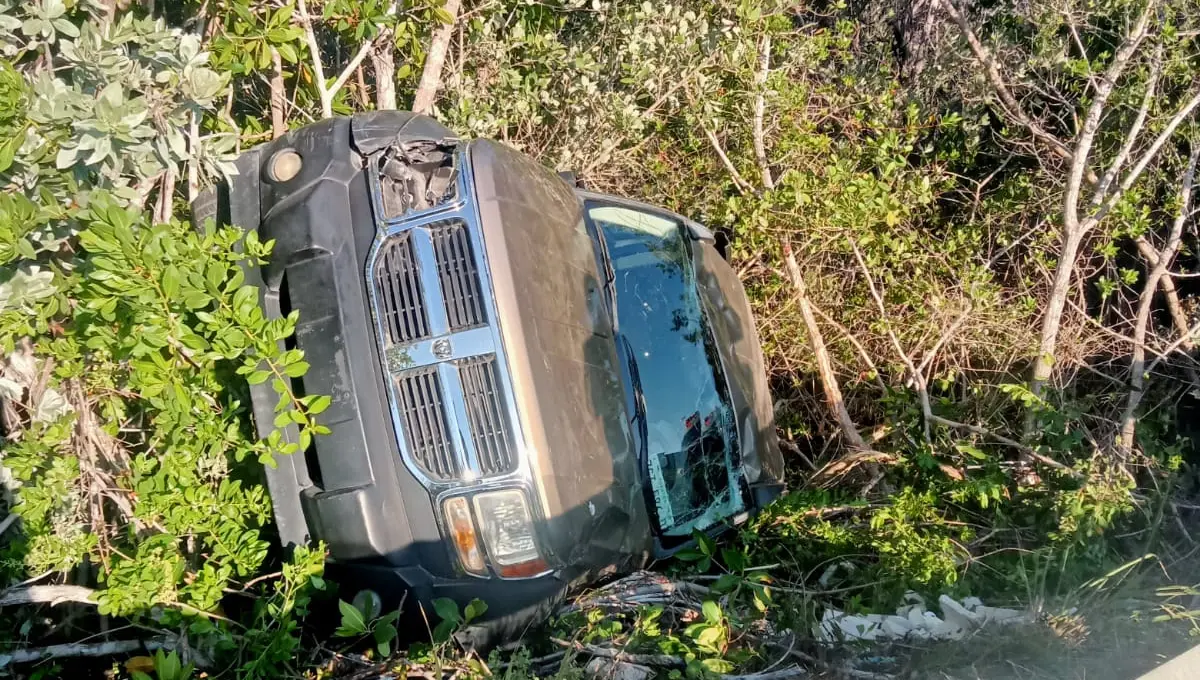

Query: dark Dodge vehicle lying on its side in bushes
[[220, 112, 784, 636]]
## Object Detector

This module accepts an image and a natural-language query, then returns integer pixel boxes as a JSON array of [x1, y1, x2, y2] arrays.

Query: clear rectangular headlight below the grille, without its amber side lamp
[[475, 489, 547, 578]]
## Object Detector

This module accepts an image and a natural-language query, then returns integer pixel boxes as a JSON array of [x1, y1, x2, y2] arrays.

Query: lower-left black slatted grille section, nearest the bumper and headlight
[[396, 368, 460, 480]]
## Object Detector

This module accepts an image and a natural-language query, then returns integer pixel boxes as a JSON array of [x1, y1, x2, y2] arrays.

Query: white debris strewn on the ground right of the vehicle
[[817, 591, 1030, 642]]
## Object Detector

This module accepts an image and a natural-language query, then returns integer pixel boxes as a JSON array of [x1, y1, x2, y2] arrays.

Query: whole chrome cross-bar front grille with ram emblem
[[365, 148, 527, 491]]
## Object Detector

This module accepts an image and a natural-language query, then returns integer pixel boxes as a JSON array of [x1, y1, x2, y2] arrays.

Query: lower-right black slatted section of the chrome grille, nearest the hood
[[458, 355, 516, 476]]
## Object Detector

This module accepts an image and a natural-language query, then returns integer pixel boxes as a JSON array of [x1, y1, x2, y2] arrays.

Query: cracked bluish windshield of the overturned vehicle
[[588, 204, 743, 536]]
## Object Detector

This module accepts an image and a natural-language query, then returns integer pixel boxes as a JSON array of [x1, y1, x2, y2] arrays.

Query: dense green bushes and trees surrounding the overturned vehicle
[[0, 0, 1200, 680]]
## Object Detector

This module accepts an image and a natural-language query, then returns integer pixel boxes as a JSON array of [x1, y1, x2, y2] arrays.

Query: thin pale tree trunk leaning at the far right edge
[[1116, 149, 1200, 459]]
